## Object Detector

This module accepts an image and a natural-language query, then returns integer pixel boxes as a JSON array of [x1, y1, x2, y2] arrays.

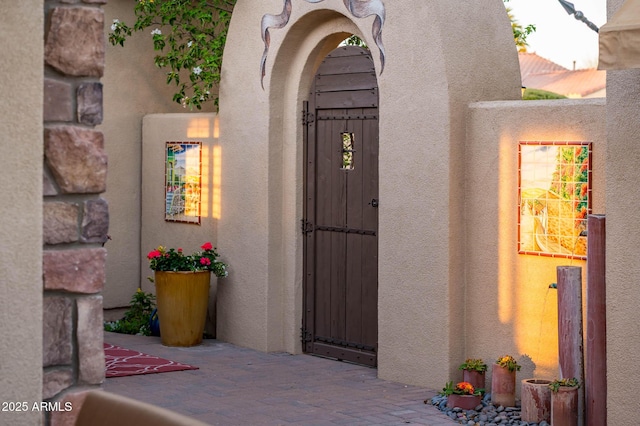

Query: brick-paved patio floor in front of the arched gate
[[104, 332, 457, 426]]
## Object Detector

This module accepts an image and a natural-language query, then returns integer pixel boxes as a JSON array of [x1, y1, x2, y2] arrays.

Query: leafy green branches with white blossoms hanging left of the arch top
[[109, 0, 236, 109]]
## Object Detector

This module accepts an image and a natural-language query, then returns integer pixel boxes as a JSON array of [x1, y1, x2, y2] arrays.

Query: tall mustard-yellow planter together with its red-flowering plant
[[147, 242, 227, 346]]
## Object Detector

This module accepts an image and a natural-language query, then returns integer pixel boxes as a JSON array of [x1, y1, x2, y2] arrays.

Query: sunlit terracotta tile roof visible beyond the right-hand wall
[[518, 53, 607, 98]]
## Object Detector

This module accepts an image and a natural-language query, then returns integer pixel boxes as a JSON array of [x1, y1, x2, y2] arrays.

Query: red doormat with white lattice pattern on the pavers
[[104, 343, 198, 378]]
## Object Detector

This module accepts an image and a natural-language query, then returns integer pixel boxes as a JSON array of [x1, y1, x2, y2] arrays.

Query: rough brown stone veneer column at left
[[42, 0, 109, 425]]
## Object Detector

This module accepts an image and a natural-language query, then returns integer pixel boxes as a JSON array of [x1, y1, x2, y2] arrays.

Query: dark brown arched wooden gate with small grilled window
[[302, 46, 379, 366]]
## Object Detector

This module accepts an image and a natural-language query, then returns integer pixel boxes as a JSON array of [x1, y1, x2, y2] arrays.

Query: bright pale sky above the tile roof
[[505, 0, 607, 69]]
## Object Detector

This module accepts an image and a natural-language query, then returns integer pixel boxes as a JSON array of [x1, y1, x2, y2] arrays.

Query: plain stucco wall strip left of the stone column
[[0, 0, 44, 426]]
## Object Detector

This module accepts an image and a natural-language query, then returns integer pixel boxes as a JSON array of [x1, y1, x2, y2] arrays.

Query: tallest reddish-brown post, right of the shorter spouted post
[[585, 215, 607, 426]]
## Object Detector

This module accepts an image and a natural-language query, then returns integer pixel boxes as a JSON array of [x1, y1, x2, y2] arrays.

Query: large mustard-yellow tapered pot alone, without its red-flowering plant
[[155, 271, 211, 346]]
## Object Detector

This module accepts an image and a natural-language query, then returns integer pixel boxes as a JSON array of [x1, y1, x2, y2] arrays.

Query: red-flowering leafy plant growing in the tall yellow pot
[[147, 242, 228, 278]]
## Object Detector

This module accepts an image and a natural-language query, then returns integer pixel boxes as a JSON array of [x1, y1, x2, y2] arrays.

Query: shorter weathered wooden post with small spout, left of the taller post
[[557, 266, 584, 426]]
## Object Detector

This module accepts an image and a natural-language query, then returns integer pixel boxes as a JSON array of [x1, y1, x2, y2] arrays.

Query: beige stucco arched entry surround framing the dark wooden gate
[[218, 0, 521, 387]]
